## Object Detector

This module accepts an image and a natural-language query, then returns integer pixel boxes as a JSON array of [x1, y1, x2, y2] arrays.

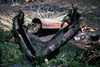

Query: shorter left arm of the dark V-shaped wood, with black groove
[[16, 28, 35, 59]]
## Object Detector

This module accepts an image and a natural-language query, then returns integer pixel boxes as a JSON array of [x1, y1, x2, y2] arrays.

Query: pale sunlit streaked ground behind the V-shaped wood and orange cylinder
[[0, 7, 67, 31]]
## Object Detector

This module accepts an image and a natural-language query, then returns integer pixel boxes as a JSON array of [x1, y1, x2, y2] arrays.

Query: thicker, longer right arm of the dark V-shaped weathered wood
[[43, 24, 80, 55]]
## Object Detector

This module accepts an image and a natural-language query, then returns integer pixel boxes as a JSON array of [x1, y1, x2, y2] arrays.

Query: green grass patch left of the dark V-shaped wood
[[0, 29, 25, 64]]
